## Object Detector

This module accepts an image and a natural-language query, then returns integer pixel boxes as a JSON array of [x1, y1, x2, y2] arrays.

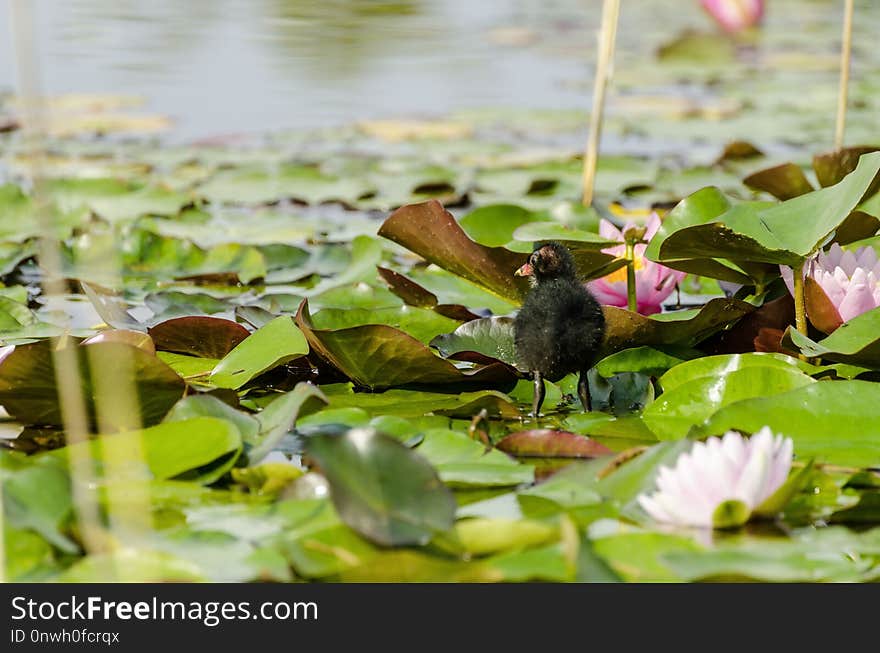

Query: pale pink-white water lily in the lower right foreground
[[638, 426, 793, 528]]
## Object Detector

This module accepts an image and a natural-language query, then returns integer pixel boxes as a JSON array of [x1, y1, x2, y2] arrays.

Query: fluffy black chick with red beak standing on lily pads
[[513, 242, 605, 417]]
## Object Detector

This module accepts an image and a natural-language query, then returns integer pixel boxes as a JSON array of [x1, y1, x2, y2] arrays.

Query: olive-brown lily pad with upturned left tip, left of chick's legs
[[296, 300, 514, 390]]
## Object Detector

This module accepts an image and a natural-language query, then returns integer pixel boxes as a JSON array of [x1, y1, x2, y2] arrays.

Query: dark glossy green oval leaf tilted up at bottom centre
[[308, 429, 456, 546]]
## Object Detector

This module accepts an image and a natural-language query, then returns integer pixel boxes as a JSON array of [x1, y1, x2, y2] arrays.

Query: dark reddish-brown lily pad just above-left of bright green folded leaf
[[147, 315, 250, 358]]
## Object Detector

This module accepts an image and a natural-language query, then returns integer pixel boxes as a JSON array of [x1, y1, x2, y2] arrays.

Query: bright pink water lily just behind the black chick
[[587, 213, 686, 315]]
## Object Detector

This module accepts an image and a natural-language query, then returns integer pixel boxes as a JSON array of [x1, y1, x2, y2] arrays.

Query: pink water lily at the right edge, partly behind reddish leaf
[[780, 243, 880, 333]]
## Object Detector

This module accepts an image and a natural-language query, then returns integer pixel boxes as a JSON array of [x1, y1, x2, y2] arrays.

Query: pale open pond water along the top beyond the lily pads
[[0, 0, 880, 146]]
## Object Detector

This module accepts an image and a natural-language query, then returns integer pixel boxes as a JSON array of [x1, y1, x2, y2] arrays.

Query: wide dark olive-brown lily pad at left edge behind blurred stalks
[[0, 341, 186, 426]]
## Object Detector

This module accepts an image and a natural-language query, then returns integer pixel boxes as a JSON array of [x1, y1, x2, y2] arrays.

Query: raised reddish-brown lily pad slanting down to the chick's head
[[379, 200, 529, 302]]
